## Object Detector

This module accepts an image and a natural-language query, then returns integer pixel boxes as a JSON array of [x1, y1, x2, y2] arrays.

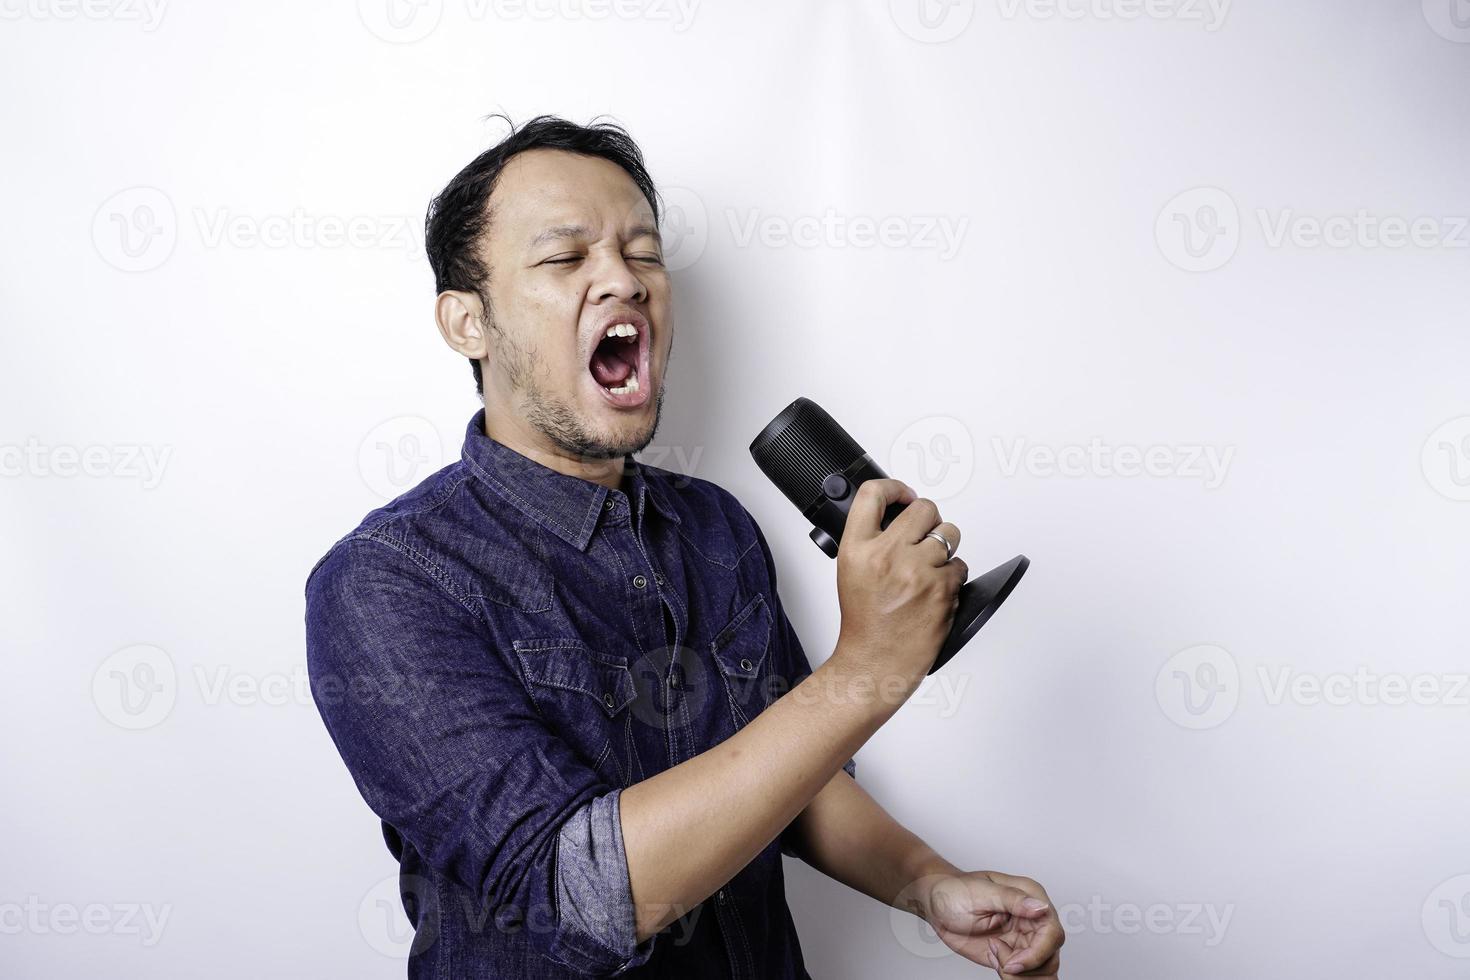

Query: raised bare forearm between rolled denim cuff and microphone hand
[[620, 648, 903, 942]]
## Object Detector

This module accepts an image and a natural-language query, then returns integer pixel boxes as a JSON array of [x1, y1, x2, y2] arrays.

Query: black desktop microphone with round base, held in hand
[[750, 398, 1030, 674]]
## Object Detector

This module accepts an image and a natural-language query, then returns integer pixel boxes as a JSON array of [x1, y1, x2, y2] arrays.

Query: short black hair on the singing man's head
[[423, 113, 659, 394]]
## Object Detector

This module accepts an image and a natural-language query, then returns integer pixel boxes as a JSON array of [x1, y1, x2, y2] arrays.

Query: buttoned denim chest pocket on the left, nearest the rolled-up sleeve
[[513, 636, 641, 786]]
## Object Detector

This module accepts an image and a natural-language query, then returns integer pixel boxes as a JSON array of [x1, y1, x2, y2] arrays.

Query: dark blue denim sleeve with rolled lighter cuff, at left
[[306, 538, 656, 976]]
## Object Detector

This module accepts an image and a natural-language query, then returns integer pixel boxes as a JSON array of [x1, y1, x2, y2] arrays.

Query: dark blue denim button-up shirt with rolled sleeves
[[306, 410, 856, 980]]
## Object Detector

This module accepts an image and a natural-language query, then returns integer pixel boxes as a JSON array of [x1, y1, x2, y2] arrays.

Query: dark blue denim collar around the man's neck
[[462, 408, 682, 551]]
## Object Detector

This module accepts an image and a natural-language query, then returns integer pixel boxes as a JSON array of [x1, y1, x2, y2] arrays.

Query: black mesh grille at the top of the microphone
[[750, 398, 864, 511]]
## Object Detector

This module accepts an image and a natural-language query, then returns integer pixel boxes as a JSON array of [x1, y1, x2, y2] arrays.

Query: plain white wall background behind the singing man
[[0, 0, 1470, 980]]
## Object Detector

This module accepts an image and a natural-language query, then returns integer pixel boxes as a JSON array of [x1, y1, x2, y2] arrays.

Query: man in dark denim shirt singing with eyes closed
[[306, 116, 1063, 979]]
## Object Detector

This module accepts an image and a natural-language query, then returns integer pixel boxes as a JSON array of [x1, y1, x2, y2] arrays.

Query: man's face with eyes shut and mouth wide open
[[482, 150, 673, 458]]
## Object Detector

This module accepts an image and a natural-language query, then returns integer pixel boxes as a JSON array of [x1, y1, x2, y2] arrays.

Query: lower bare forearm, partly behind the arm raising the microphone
[[791, 773, 961, 917]]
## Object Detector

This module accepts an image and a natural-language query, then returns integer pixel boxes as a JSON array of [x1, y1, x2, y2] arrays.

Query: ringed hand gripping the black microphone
[[836, 479, 969, 692]]
